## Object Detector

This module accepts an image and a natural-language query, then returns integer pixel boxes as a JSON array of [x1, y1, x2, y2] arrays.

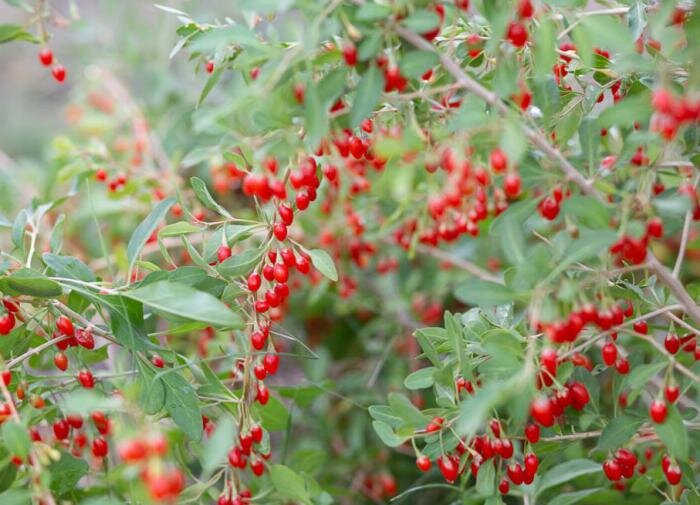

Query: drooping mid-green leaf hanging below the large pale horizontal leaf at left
[[160, 371, 202, 440]]
